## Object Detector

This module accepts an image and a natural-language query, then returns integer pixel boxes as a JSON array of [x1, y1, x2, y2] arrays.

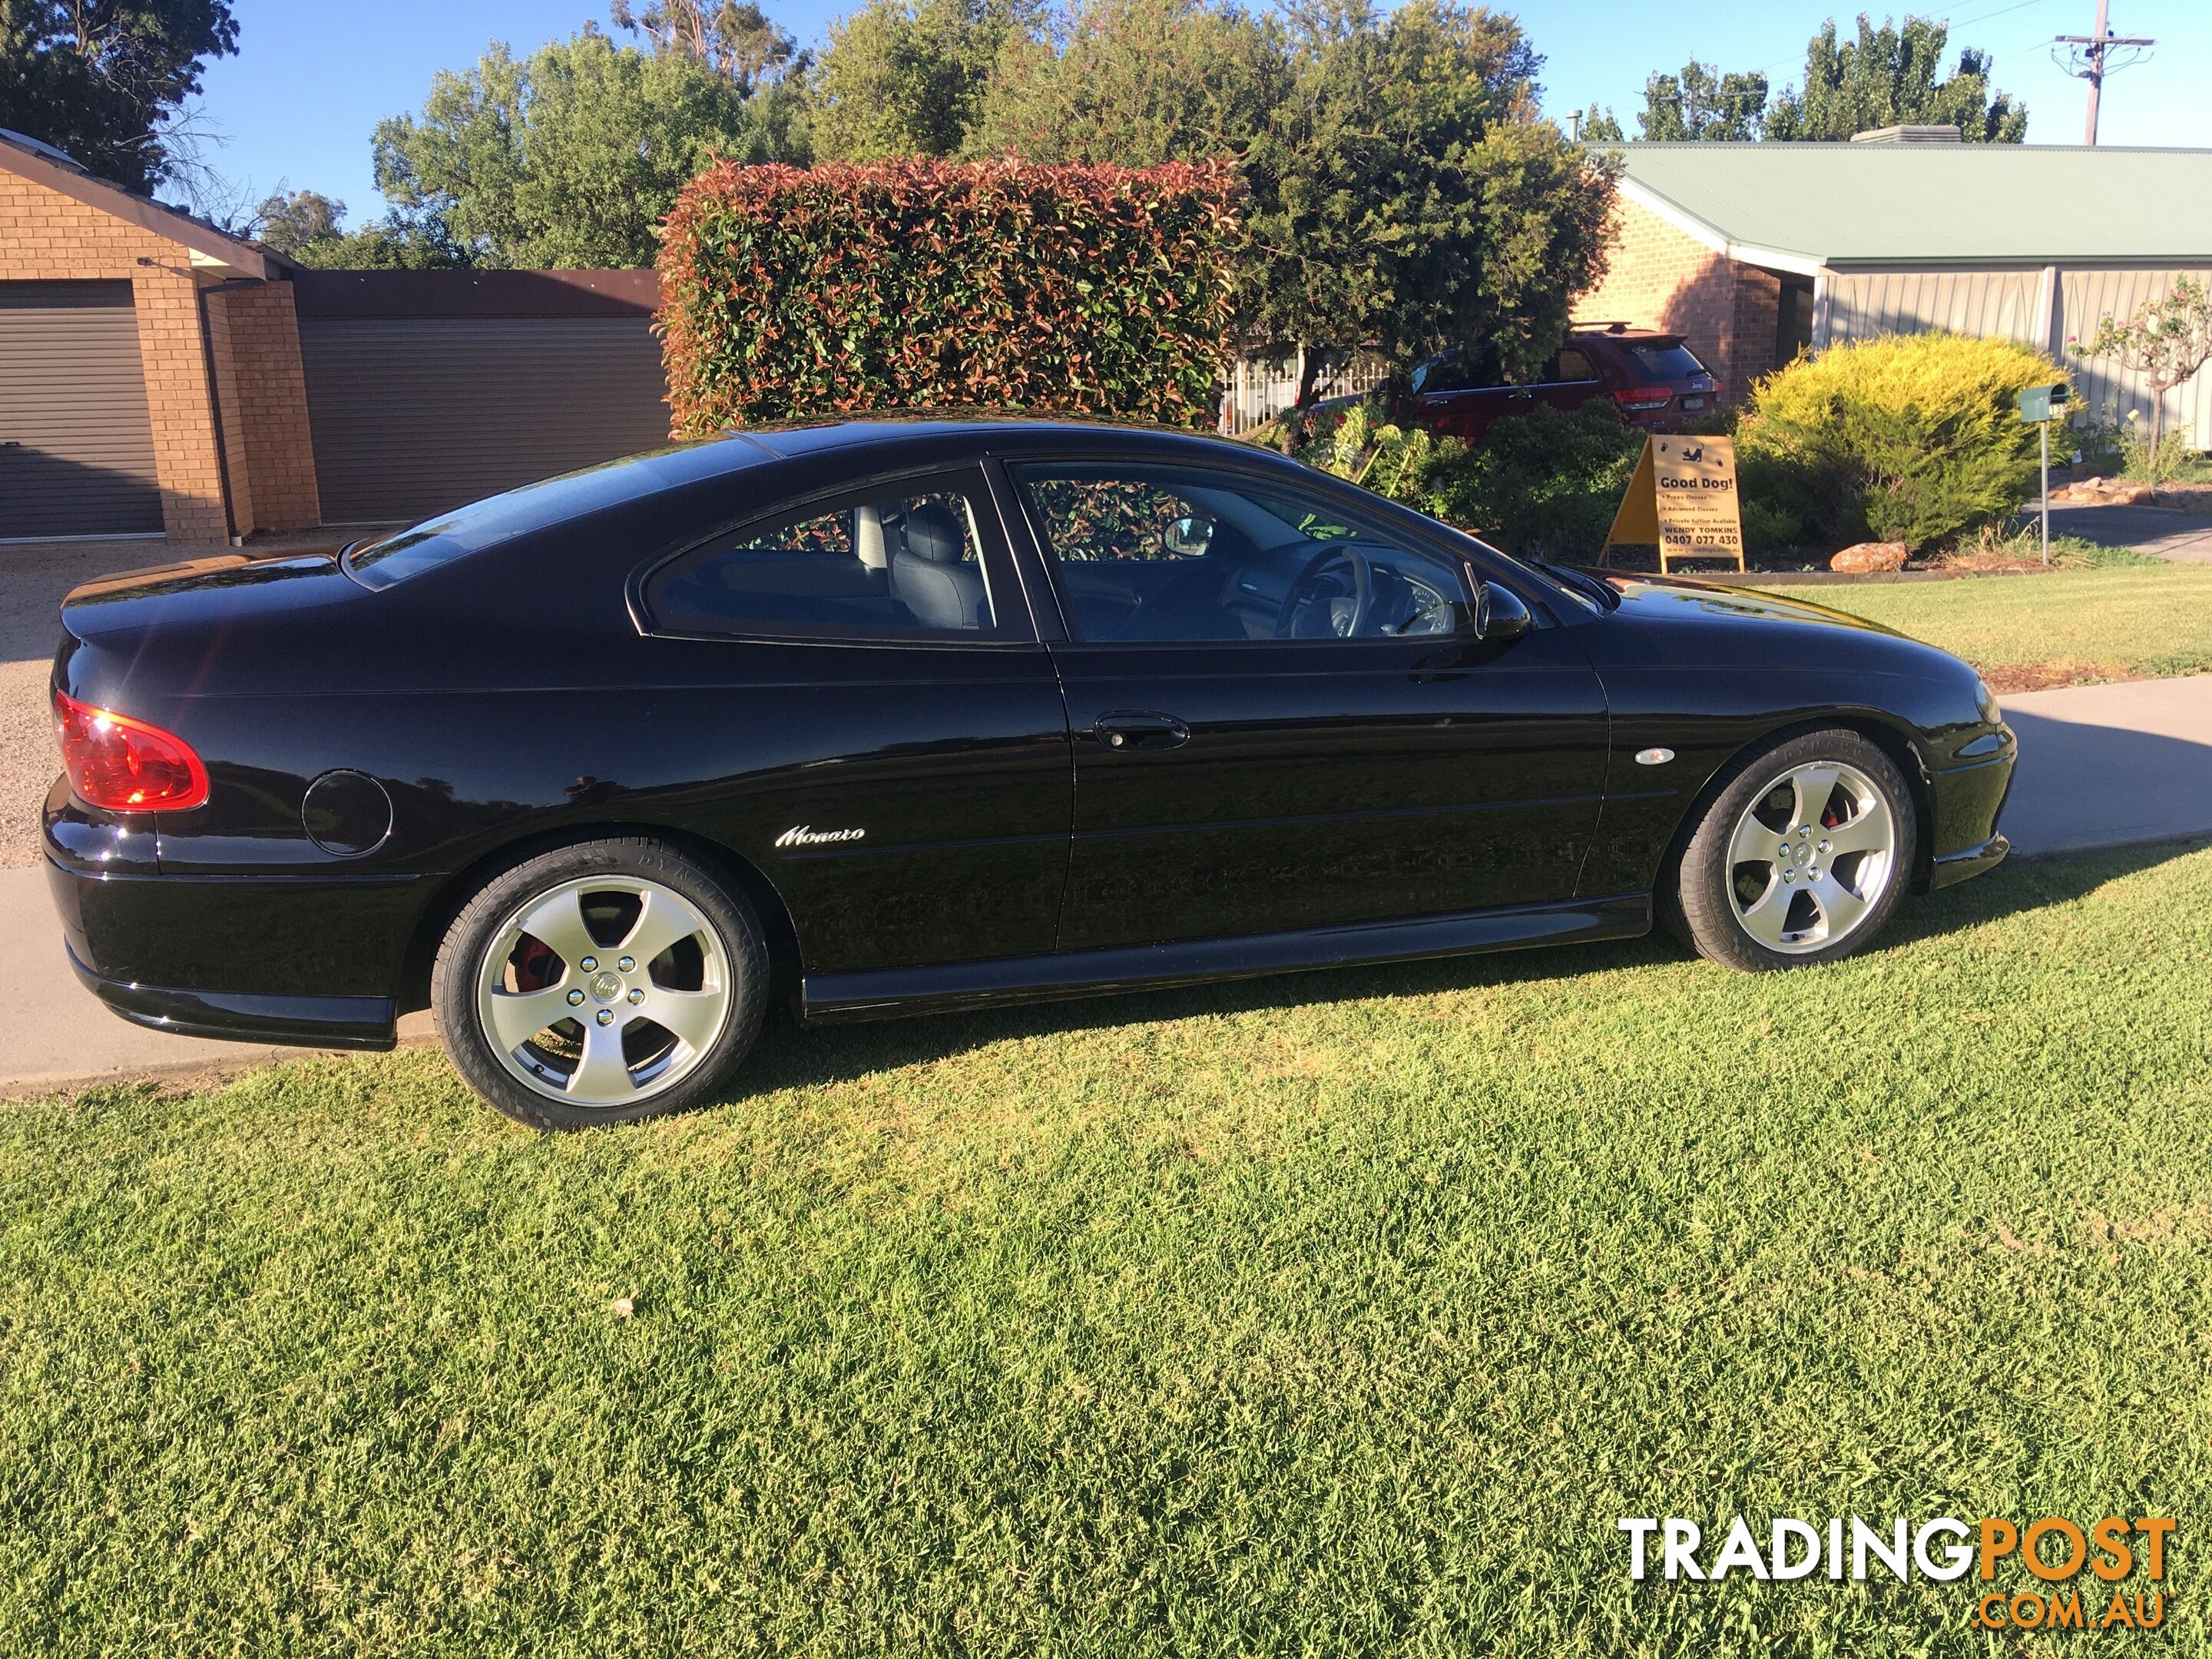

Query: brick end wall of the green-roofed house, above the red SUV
[[1575, 197, 1780, 402]]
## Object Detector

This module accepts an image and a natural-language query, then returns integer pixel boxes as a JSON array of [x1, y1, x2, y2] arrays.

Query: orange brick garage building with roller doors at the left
[[0, 133, 668, 542]]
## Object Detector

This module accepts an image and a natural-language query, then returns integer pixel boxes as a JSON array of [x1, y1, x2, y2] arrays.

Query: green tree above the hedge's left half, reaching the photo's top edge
[[807, 0, 1044, 161]]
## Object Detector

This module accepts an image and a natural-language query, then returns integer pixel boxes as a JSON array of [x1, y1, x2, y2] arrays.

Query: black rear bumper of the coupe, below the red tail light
[[46, 854, 412, 1048]]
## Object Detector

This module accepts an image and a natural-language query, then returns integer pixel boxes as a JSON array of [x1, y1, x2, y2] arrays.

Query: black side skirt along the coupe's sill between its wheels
[[801, 894, 1652, 1024]]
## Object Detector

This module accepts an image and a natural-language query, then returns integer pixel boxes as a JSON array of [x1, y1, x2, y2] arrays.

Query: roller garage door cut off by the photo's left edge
[[0, 283, 161, 540]]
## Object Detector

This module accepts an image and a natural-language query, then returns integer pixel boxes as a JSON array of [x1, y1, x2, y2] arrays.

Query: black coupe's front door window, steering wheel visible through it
[[1015, 462, 1466, 644]]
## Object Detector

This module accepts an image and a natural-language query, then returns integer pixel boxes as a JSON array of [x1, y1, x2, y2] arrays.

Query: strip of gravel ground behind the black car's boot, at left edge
[[0, 533, 339, 869]]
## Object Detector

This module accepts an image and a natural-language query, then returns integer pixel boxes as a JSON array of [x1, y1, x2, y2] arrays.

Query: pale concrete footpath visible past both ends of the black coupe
[[0, 674, 2212, 1097]]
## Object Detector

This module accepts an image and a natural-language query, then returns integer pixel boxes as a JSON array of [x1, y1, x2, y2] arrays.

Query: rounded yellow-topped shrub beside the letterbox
[[1737, 334, 2066, 548]]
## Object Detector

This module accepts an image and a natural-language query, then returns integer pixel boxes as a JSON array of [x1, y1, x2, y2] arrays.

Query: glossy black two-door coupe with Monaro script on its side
[[45, 418, 2013, 1126]]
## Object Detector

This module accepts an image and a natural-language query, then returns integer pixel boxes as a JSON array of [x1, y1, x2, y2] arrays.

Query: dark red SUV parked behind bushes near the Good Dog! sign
[[1389, 323, 1721, 442]]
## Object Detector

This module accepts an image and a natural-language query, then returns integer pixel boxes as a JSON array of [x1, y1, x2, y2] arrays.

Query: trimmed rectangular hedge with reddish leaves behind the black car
[[659, 159, 1237, 435]]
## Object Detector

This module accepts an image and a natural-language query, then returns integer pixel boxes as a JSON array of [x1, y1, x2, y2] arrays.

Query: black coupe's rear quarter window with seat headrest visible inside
[[646, 485, 995, 637]]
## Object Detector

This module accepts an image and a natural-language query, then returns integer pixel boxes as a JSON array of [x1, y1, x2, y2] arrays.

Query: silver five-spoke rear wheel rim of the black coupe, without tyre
[[475, 874, 734, 1106]]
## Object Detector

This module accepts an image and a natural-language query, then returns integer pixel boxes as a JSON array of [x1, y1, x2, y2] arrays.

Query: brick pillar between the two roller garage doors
[[208, 283, 323, 531]]
